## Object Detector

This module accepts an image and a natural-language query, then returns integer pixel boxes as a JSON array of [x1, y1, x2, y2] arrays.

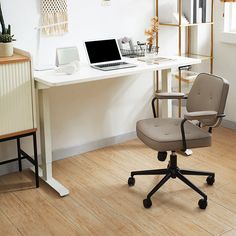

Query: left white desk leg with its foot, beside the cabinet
[[35, 89, 69, 196]]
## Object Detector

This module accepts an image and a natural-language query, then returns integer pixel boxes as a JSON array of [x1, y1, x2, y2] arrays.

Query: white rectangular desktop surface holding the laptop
[[34, 56, 201, 89]]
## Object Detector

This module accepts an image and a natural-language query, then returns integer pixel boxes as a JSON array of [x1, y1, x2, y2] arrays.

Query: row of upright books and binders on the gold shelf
[[182, 0, 211, 24]]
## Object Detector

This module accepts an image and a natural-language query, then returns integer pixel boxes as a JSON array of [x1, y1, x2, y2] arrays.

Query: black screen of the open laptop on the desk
[[85, 39, 121, 64]]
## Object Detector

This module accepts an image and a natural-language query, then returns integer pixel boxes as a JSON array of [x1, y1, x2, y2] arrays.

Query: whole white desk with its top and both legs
[[34, 57, 201, 196]]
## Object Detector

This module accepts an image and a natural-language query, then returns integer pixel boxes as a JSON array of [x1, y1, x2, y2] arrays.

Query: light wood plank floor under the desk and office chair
[[0, 128, 236, 236]]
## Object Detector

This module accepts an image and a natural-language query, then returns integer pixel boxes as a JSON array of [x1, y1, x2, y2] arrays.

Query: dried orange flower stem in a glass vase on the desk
[[145, 16, 159, 64]]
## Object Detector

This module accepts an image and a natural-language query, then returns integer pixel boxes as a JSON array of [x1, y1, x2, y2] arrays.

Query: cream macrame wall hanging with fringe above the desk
[[41, 0, 68, 36]]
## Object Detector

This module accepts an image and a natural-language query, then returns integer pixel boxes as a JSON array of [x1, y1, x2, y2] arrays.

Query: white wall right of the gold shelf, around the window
[[214, 1, 236, 122]]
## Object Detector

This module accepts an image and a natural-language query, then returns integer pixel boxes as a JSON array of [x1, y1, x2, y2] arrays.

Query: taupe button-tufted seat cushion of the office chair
[[136, 118, 211, 151]]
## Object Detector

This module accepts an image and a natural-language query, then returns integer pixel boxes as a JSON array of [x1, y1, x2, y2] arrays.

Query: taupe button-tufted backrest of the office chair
[[186, 73, 229, 127]]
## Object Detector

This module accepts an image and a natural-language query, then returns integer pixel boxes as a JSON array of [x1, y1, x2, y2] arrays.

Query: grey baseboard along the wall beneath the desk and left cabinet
[[0, 132, 137, 176]]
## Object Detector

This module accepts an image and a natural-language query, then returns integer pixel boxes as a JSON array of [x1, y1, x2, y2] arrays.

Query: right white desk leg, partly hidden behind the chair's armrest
[[161, 69, 172, 118]]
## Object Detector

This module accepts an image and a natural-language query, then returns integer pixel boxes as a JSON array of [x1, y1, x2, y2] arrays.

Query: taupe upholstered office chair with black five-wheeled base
[[128, 73, 229, 209]]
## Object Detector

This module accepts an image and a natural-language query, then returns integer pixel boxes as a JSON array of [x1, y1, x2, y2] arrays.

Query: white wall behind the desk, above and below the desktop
[[0, 0, 155, 172]]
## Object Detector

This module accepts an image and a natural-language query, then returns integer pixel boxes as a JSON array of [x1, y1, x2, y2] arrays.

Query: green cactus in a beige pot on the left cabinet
[[0, 3, 15, 57]]
